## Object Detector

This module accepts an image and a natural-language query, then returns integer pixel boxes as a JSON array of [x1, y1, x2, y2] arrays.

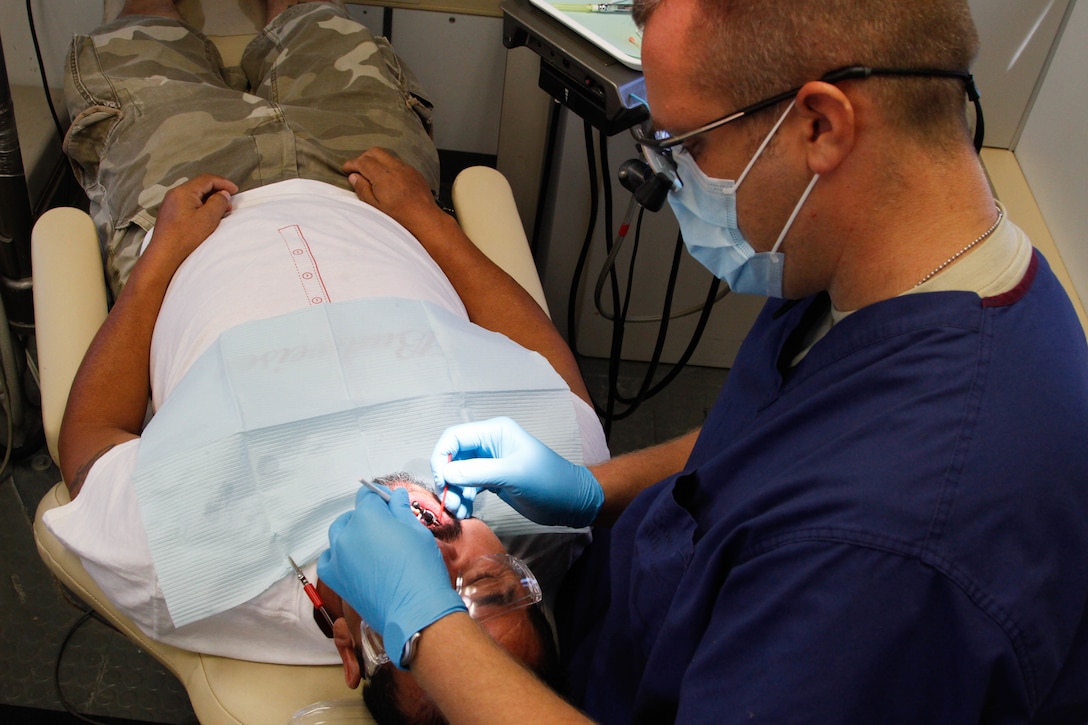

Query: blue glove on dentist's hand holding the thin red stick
[[431, 418, 605, 527]]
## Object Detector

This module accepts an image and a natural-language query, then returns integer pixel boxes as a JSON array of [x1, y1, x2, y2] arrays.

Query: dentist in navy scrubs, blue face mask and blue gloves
[[319, 0, 1088, 725]]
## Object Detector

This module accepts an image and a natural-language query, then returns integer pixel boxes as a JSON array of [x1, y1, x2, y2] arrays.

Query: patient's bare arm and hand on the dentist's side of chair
[[344, 148, 589, 402]]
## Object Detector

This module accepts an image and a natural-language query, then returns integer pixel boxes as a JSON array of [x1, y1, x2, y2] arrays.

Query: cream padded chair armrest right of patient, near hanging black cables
[[453, 167, 551, 317]]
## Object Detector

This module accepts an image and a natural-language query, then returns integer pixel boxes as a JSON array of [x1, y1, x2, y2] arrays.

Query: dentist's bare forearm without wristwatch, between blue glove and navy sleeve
[[590, 430, 698, 526]]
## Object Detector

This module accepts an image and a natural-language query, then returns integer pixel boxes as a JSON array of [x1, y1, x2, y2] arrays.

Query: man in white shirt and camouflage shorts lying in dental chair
[[45, 0, 608, 709]]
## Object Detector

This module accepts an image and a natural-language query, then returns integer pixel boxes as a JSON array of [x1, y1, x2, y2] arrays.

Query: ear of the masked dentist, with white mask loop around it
[[794, 81, 857, 175]]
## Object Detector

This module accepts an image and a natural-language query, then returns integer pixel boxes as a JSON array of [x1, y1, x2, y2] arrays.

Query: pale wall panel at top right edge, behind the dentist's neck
[[1014, 2, 1088, 304]]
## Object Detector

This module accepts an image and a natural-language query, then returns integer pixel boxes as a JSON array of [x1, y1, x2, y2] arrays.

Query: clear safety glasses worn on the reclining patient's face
[[359, 554, 543, 678]]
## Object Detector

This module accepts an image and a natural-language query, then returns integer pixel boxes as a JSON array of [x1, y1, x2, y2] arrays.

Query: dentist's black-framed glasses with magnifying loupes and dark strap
[[631, 65, 982, 174]]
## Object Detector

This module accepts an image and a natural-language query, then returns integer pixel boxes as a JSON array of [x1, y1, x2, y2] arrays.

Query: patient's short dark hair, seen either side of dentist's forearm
[[362, 604, 559, 725]]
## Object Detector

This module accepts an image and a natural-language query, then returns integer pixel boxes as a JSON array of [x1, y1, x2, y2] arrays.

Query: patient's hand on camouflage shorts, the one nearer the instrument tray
[[344, 148, 444, 237]]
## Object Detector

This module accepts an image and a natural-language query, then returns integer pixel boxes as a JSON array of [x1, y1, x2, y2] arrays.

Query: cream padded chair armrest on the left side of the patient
[[30, 207, 108, 460]]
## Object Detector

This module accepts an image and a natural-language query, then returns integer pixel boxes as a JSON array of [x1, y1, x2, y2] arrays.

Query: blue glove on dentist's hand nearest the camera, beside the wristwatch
[[318, 487, 467, 667]]
